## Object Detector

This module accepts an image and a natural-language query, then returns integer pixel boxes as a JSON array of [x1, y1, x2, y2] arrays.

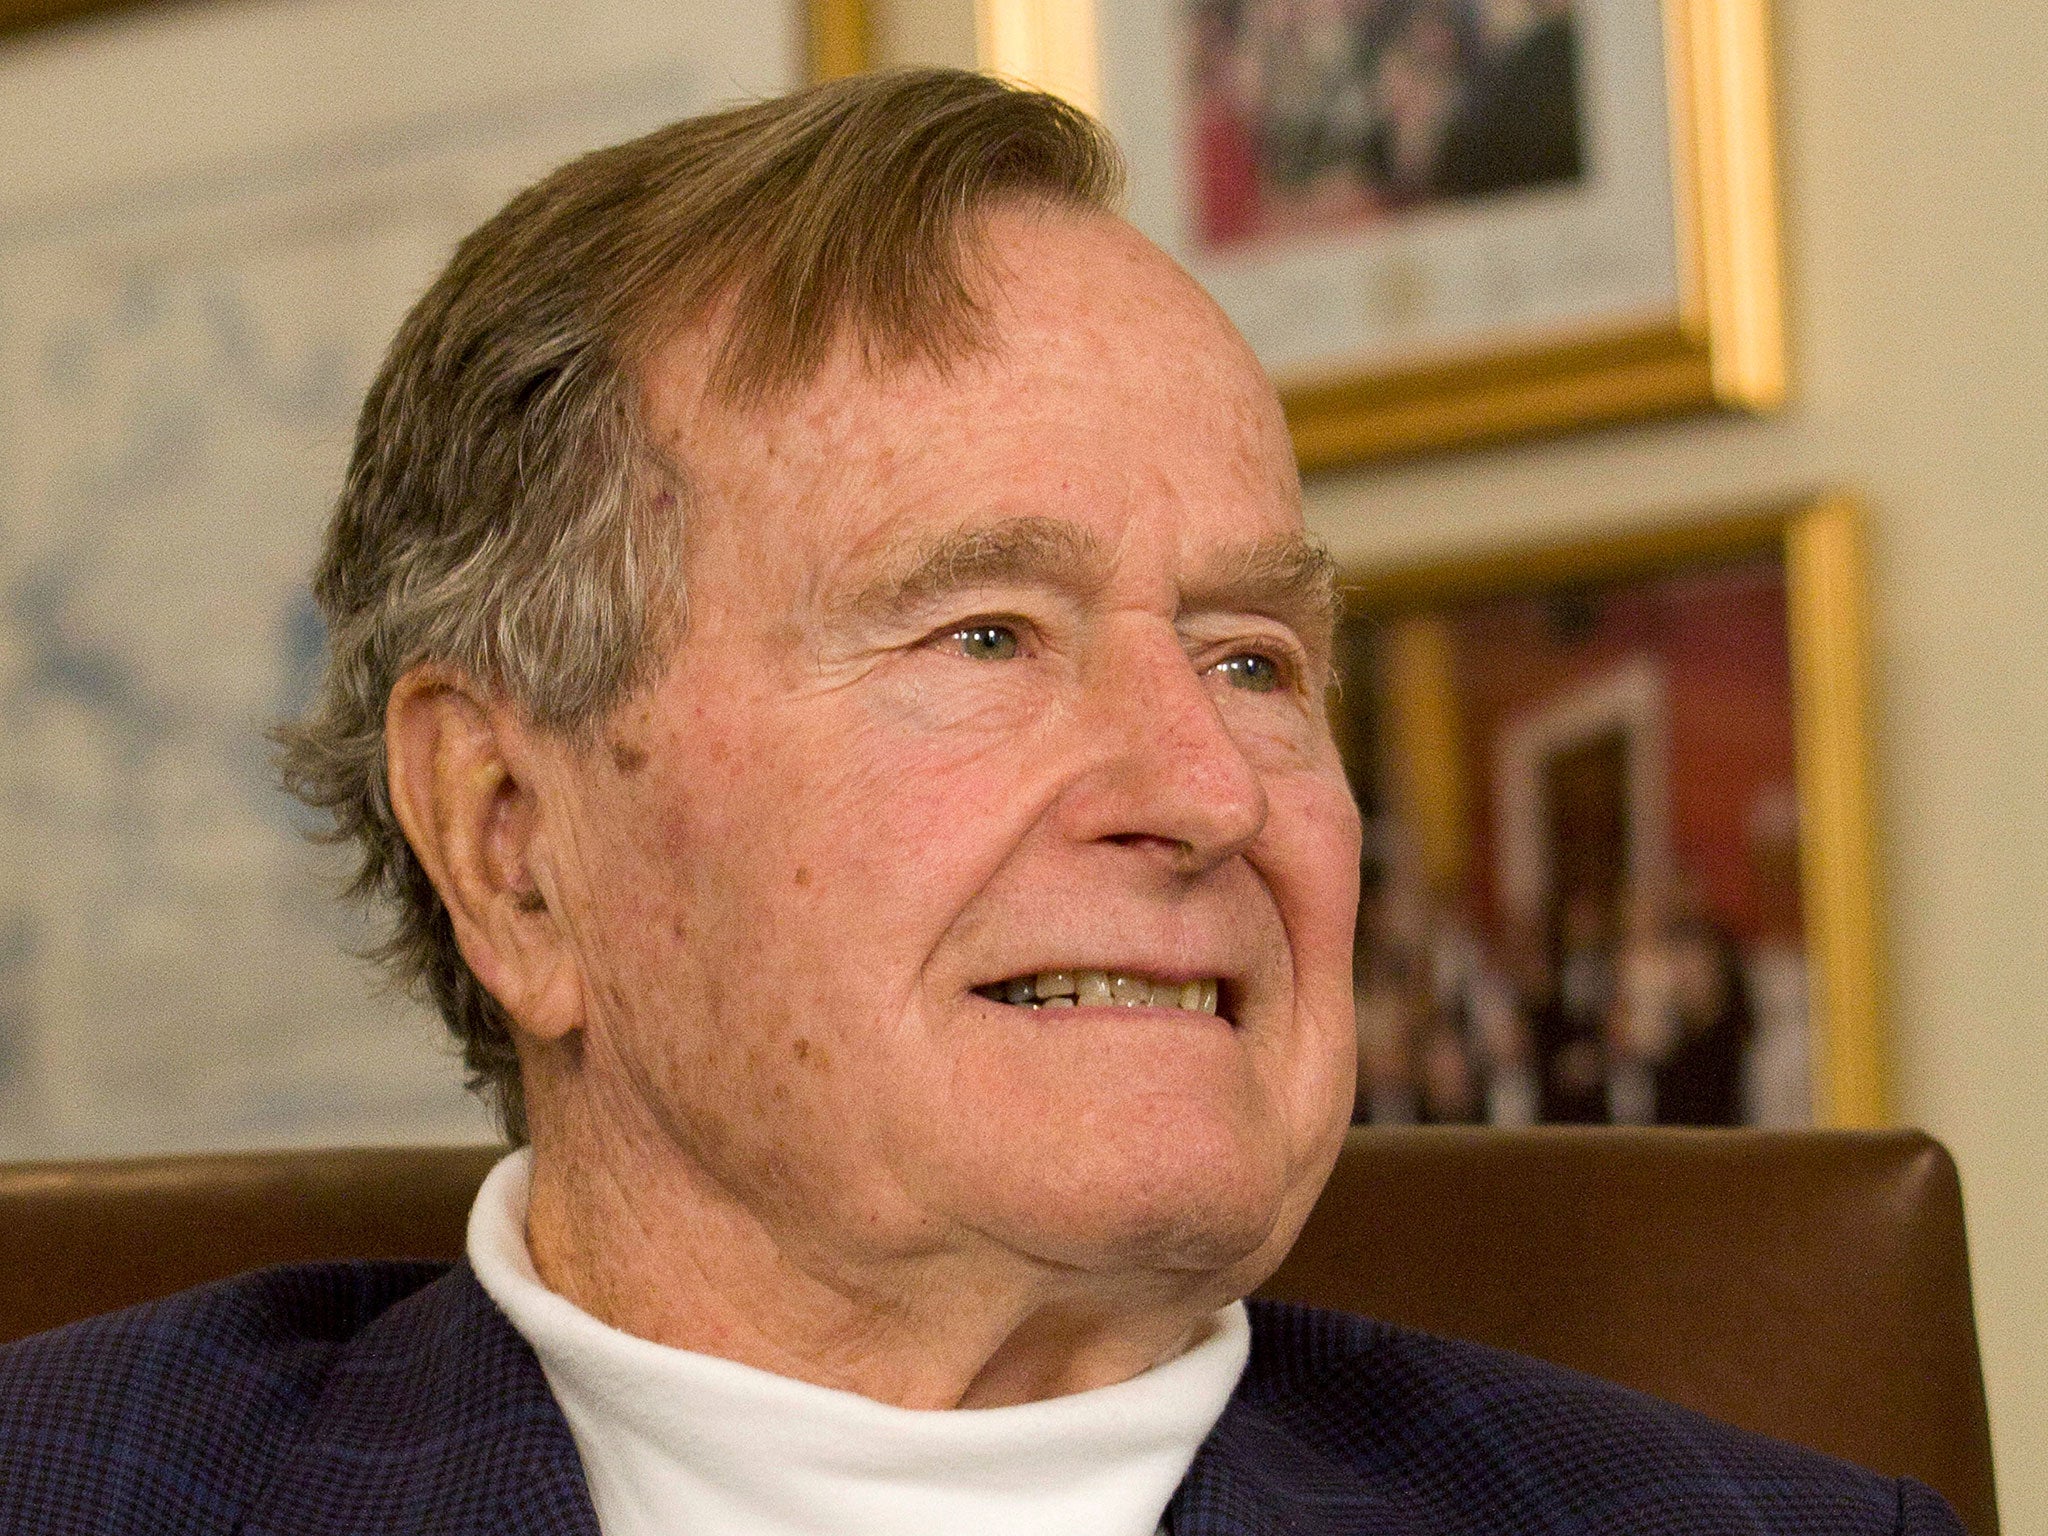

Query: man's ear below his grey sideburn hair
[[385, 666, 584, 1040]]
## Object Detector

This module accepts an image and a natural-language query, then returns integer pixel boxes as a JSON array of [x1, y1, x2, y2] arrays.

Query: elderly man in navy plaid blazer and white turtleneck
[[0, 74, 1954, 1536]]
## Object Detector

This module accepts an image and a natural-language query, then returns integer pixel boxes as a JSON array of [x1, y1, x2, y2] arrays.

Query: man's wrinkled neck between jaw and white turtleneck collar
[[526, 1124, 1231, 1409]]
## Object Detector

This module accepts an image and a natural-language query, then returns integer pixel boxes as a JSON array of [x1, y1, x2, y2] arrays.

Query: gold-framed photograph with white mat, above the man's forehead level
[[979, 0, 1786, 467]]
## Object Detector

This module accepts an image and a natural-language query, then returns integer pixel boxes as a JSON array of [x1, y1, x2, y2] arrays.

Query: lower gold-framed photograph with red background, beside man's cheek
[[1333, 496, 1886, 1126]]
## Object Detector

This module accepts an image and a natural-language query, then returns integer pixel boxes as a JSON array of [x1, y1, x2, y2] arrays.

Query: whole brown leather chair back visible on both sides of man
[[0, 1130, 1997, 1536]]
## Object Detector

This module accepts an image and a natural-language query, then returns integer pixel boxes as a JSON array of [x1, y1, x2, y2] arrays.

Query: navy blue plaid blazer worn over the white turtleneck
[[0, 1264, 1962, 1536]]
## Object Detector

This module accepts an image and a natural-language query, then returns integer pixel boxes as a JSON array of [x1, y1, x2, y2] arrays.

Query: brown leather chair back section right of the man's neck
[[1266, 1128, 1997, 1536]]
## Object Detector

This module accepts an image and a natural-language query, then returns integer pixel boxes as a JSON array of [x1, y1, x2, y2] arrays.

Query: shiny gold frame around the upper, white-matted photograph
[[977, 0, 1786, 469]]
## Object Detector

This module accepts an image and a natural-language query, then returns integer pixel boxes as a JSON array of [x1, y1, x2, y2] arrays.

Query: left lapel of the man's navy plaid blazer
[[242, 1264, 598, 1536]]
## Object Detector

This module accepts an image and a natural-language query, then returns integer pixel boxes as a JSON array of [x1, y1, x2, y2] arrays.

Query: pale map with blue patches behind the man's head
[[0, 0, 799, 1159]]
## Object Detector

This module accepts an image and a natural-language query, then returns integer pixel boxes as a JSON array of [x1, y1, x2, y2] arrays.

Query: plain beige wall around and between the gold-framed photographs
[[885, 0, 2048, 1532]]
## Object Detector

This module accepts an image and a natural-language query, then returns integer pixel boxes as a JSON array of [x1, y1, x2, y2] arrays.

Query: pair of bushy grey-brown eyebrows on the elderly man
[[827, 516, 1337, 655]]
